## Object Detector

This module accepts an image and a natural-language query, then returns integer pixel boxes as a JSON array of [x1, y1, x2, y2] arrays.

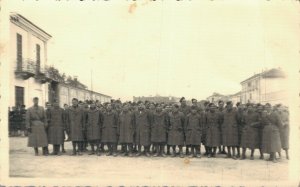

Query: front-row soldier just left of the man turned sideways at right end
[[241, 104, 262, 160]]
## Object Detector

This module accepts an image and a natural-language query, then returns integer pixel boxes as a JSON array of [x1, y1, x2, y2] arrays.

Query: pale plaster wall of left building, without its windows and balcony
[[9, 22, 48, 107]]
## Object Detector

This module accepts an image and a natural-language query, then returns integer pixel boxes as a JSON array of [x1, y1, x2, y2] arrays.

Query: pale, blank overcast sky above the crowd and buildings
[[7, 0, 300, 100]]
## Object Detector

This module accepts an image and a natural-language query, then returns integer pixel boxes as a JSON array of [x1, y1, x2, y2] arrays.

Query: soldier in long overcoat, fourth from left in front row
[[86, 103, 102, 156]]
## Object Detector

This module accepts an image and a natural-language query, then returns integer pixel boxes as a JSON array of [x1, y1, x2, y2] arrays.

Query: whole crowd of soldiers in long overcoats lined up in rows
[[26, 97, 289, 162]]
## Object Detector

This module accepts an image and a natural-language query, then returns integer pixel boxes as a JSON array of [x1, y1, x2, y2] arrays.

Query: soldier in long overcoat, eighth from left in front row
[[151, 104, 168, 157]]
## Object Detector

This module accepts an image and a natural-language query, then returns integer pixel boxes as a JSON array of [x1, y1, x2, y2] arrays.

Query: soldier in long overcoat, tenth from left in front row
[[185, 106, 203, 158]]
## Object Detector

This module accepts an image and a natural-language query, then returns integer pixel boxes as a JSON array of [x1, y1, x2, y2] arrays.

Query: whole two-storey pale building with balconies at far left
[[9, 13, 51, 107]]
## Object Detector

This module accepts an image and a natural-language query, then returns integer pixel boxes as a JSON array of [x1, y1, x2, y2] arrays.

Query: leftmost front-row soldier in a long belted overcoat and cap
[[26, 97, 48, 156]]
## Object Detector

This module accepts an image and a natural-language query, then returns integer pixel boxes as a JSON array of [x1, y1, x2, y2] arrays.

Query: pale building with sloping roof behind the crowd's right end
[[241, 69, 288, 105]]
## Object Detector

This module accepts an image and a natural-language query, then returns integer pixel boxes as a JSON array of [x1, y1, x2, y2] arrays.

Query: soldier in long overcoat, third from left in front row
[[67, 98, 84, 155]]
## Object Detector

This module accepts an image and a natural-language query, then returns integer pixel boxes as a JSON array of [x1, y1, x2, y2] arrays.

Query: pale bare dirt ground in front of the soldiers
[[9, 137, 296, 185]]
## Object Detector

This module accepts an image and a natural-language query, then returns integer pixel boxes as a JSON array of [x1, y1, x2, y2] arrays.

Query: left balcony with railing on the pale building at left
[[15, 59, 37, 80]]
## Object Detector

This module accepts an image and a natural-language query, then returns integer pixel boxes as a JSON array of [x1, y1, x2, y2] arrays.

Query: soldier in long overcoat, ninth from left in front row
[[168, 104, 185, 158]]
